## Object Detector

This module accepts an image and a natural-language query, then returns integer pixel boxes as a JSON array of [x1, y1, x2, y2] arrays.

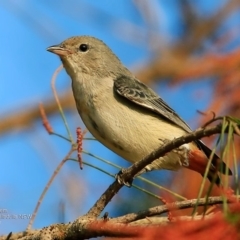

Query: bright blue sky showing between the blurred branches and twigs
[[0, 0, 237, 234]]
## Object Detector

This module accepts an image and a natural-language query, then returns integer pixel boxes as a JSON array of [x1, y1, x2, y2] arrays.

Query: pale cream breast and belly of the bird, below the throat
[[72, 76, 188, 170]]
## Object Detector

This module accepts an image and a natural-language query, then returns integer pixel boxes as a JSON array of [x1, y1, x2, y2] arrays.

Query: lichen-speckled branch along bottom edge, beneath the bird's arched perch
[[0, 197, 237, 240]]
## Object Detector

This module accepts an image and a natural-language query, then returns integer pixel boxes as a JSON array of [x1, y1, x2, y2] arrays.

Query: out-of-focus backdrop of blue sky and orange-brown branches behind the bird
[[0, 0, 240, 234]]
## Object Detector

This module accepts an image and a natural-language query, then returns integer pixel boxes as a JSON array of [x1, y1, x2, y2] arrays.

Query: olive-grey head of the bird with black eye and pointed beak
[[47, 36, 126, 78]]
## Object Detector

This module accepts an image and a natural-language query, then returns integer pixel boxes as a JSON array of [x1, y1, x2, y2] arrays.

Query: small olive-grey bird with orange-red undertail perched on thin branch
[[47, 36, 232, 185]]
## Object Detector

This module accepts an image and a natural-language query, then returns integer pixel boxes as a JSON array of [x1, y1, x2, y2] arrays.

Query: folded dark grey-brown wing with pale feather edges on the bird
[[114, 75, 191, 132]]
